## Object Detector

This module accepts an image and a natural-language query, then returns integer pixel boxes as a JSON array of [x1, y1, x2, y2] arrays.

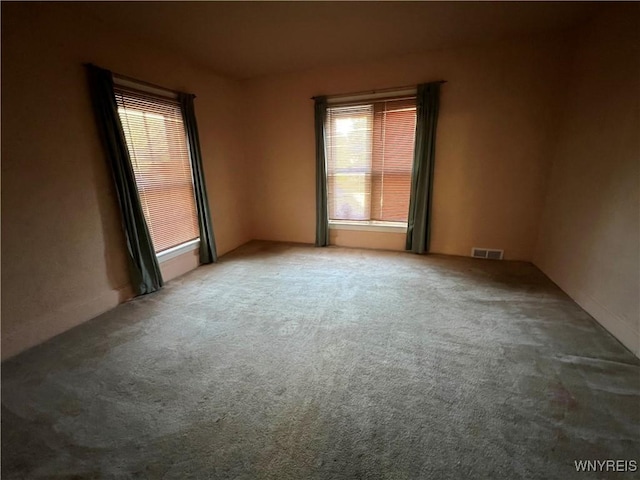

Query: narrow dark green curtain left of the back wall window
[[315, 97, 329, 247]]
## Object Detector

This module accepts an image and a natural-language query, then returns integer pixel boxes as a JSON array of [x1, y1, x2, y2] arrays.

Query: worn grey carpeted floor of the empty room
[[2, 242, 640, 480]]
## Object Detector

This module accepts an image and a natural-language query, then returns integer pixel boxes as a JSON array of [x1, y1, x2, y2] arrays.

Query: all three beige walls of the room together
[[1, 3, 640, 358]]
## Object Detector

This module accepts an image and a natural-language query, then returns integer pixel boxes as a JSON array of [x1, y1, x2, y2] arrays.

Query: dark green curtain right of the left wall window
[[178, 93, 218, 264]]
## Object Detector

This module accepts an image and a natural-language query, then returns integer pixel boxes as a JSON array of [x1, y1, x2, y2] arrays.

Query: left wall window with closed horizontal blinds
[[115, 86, 199, 254]]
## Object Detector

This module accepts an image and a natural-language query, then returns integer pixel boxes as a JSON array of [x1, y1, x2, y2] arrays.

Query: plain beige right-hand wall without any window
[[535, 3, 640, 356]]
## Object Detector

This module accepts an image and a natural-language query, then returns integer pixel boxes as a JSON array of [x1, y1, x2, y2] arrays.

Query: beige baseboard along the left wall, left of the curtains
[[1, 285, 133, 361]]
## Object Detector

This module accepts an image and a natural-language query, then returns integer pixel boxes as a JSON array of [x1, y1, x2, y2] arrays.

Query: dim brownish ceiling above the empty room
[[74, 1, 602, 79]]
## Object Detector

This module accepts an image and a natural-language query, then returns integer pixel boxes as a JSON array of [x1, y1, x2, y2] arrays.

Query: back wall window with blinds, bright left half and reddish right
[[326, 98, 416, 227]]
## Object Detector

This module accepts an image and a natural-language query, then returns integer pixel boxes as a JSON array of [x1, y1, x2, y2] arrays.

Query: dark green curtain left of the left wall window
[[87, 65, 163, 295]]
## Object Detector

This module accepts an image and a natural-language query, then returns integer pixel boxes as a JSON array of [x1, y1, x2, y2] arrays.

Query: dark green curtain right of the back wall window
[[406, 82, 442, 253]]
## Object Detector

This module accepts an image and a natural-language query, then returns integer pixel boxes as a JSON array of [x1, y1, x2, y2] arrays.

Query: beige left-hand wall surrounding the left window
[[2, 2, 251, 358]]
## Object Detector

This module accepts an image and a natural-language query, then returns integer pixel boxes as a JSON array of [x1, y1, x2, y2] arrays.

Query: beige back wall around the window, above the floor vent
[[245, 39, 566, 260]]
